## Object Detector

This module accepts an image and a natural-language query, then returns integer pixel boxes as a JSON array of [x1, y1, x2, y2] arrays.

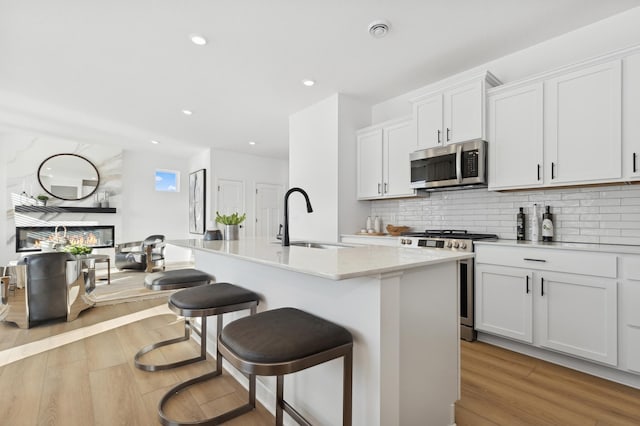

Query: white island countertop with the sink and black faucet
[[167, 238, 473, 280]]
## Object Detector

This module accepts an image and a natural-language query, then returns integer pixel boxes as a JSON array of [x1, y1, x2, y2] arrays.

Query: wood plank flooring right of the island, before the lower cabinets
[[456, 342, 640, 426]]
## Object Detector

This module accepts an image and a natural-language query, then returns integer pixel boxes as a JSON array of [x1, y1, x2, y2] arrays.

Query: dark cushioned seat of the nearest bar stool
[[221, 308, 353, 364]]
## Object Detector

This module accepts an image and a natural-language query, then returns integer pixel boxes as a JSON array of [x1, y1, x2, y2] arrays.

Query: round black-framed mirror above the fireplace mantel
[[38, 154, 100, 200]]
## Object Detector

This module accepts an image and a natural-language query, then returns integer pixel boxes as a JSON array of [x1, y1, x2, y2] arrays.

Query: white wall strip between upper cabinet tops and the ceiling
[[372, 7, 640, 123]]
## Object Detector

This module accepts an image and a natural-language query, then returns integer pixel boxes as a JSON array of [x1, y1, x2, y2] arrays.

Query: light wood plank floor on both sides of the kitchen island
[[0, 300, 640, 426]]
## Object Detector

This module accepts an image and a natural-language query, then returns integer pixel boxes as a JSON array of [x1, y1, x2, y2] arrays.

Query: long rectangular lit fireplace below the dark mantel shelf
[[16, 225, 115, 253]]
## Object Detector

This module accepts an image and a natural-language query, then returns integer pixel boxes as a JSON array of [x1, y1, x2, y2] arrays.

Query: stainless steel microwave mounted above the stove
[[410, 139, 487, 190]]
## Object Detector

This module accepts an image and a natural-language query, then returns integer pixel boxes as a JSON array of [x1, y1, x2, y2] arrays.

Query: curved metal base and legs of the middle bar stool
[[158, 302, 257, 426]]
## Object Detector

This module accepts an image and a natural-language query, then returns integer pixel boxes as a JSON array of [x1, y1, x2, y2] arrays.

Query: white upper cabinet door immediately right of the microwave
[[488, 82, 543, 190]]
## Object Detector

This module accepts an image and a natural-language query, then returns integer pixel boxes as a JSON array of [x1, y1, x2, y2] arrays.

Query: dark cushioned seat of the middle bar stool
[[169, 283, 260, 310]]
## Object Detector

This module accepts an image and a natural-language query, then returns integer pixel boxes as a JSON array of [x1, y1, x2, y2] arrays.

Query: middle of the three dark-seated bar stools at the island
[[156, 283, 260, 426]]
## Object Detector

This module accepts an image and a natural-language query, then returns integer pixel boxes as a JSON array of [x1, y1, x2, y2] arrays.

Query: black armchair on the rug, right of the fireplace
[[115, 235, 165, 272]]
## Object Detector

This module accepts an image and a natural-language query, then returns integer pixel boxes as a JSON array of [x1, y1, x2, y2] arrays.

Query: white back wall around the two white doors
[[207, 150, 289, 237]]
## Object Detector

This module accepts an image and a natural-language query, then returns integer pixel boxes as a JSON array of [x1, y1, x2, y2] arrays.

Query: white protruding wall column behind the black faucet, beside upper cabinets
[[289, 94, 370, 241]]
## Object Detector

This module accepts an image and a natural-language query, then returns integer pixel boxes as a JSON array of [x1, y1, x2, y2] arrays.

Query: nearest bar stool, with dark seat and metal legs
[[218, 308, 353, 426]]
